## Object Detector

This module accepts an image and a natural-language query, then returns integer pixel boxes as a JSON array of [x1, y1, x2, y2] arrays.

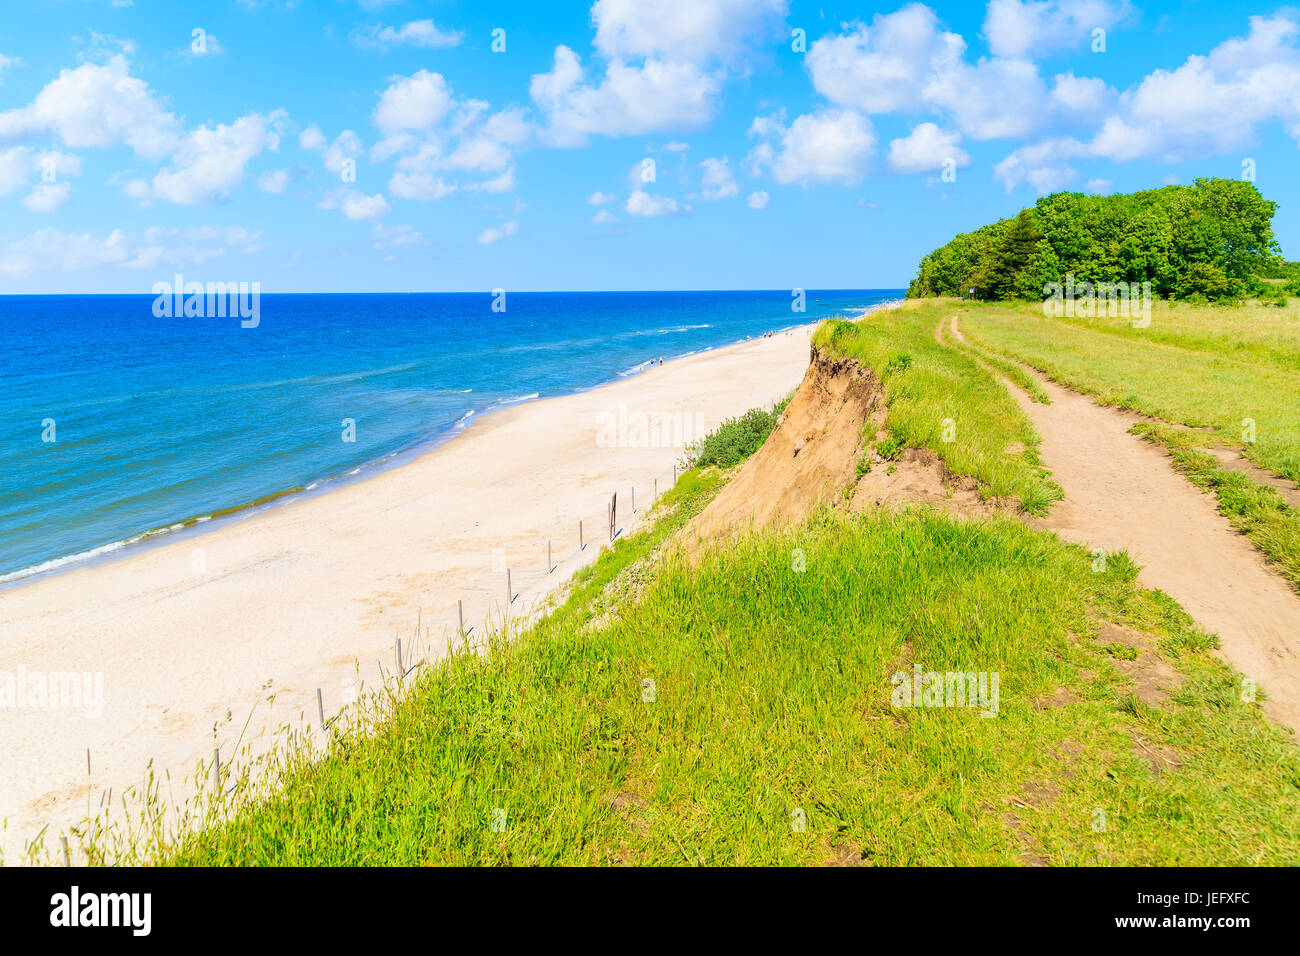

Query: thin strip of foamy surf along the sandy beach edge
[[0, 321, 832, 594]]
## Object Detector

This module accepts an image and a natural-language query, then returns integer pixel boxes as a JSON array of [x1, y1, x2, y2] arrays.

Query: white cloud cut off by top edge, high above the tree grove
[[984, 0, 1132, 57]]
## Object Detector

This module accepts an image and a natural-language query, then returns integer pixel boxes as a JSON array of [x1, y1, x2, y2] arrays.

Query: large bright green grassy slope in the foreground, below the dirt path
[[164, 504, 1300, 865]]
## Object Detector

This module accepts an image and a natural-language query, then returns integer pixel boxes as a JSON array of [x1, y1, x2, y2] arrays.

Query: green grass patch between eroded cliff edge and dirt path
[[813, 303, 1061, 514]]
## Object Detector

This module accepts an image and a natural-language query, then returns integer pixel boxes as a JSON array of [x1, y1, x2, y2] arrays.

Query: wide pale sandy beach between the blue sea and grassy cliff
[[0, 326, 811, 864]]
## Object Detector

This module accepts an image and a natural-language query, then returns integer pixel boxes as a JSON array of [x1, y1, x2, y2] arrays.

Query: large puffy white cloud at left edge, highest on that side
[[0, 55, 182, 159]]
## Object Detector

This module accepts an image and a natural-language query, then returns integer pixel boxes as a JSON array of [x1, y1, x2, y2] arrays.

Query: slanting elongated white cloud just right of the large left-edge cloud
[[151, 111, 285, 206]]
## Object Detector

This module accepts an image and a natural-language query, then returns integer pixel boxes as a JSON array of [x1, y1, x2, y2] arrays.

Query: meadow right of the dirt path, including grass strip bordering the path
[[959, 303, 1300, 587]]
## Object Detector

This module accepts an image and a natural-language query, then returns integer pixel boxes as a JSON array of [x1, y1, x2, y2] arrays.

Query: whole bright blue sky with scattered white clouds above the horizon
[[0, 0, 1300, 293]]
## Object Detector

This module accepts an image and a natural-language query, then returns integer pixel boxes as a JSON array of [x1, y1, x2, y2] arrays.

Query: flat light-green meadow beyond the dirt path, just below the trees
[[959, 303, 1300, 481]]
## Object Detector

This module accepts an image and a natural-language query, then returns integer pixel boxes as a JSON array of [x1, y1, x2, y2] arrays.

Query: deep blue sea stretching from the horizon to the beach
[[0, 289, 904, 584]]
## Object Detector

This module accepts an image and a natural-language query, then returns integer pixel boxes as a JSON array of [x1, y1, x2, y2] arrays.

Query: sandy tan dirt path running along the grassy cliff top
[[935, 316, 1300, 731]]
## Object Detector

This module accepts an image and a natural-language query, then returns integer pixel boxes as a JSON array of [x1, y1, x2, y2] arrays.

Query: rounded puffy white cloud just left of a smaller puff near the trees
[[749, 109, 876, 185]]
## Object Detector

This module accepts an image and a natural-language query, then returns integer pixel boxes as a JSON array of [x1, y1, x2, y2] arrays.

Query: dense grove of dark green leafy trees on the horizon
[[907, 178, 1284, 302]]
